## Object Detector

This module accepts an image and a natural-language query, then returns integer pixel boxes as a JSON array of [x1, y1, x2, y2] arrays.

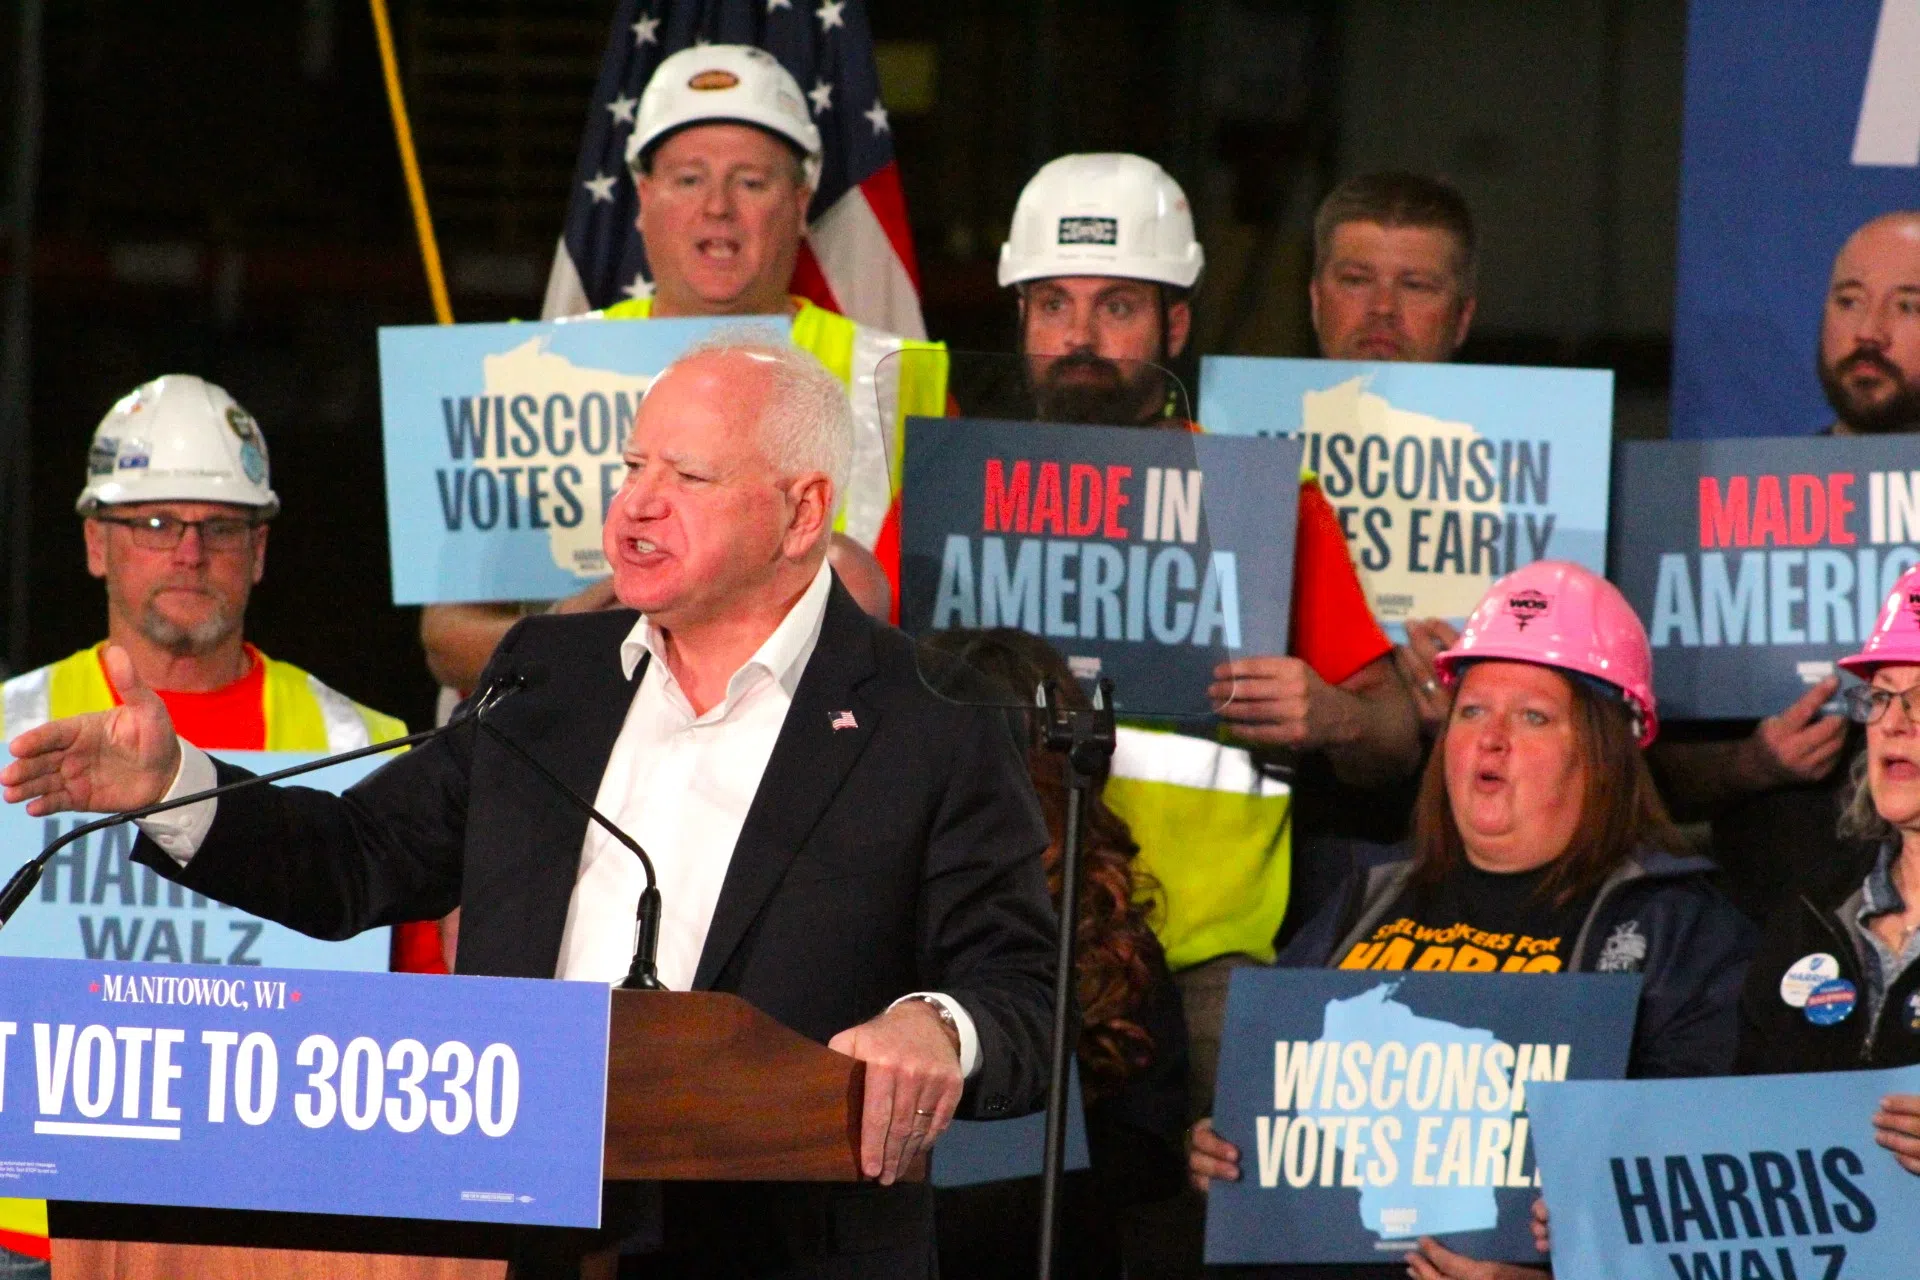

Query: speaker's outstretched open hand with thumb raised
[[0, 645, 180, 818]]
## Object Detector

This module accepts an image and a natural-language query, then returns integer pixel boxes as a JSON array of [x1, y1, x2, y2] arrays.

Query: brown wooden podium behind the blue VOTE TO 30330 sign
[[48, 990, 866, 1280]]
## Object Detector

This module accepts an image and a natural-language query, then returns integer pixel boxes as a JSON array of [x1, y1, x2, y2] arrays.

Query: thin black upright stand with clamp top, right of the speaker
[[1039, 677, 1116, 1280]]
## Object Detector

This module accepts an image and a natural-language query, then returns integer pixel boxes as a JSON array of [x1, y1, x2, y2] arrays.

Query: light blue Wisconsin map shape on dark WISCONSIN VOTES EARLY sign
[[1300, 983, 1500, 1240]]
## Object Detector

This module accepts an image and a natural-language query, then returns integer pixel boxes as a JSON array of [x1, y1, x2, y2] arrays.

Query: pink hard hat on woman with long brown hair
[[1434, 560, 1661, 747]]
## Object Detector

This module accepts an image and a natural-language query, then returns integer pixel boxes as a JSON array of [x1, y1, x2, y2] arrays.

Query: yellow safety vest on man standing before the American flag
[[599, 297, 947, 547]]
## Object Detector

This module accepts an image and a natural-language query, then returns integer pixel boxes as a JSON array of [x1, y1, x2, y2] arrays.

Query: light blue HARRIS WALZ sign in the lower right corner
[[1534, 1067, 1920, 1280]]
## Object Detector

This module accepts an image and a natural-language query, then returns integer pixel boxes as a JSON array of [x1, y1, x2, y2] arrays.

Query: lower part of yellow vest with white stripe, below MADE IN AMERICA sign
[[1106, 725, 1292, 969]]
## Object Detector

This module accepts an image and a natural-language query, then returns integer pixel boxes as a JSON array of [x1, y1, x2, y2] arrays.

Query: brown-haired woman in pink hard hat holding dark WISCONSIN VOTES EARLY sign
[[1188, 560, 1753, 1280]]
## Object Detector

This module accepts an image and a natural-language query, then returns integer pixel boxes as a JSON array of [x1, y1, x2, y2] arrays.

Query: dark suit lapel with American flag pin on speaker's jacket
[[693, 580, 879, 990]]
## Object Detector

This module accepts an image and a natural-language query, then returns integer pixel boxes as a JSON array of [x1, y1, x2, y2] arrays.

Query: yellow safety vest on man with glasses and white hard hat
[[0, 643, 407, 1240]]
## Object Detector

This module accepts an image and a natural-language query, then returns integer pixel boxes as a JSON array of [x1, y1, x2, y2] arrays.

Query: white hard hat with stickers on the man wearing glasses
[[73, 374, 280, 518]]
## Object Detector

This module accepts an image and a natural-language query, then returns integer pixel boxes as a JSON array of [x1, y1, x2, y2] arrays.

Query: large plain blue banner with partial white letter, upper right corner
[[1672, 0, 1920, 439]]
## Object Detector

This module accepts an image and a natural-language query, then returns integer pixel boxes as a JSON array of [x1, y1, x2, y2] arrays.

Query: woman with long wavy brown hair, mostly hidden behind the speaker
[[924, 628, 1187, 1280]]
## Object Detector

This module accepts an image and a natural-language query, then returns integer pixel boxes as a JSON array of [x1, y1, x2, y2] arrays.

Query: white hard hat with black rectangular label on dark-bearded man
[[1000, 152, 1206, 290]]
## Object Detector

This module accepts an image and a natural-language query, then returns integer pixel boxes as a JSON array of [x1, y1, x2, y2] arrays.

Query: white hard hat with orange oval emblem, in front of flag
[[626, 44, 820, 186]]
